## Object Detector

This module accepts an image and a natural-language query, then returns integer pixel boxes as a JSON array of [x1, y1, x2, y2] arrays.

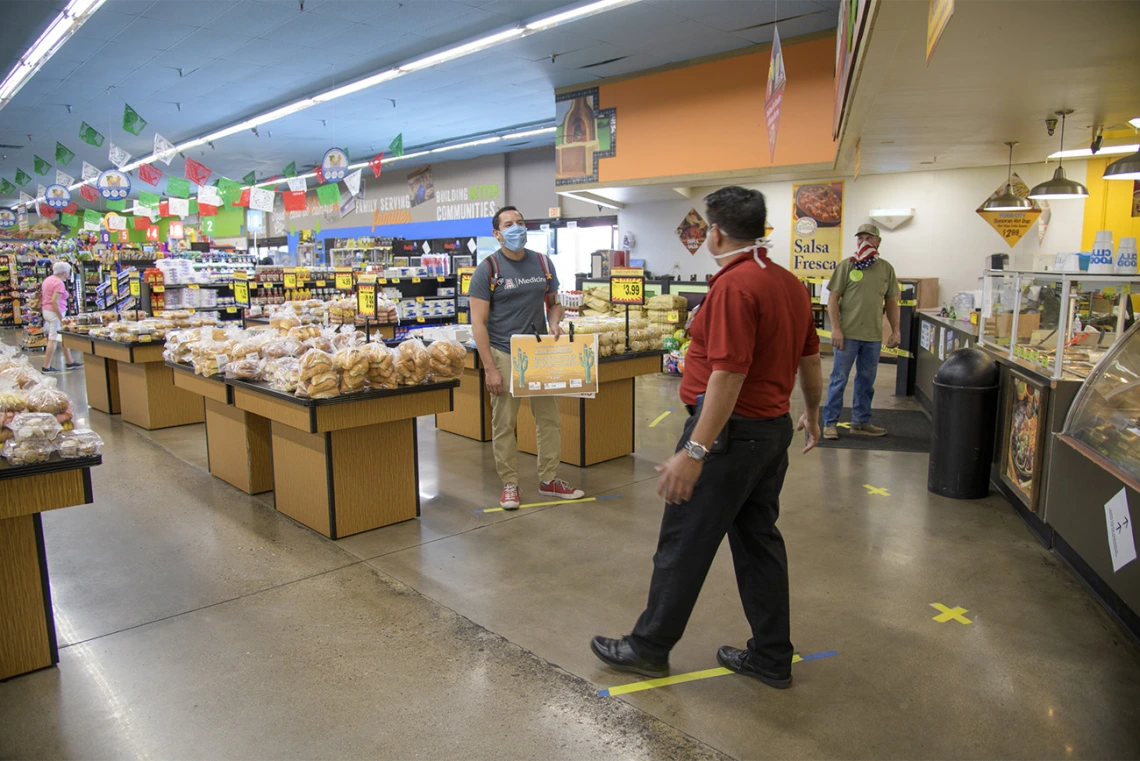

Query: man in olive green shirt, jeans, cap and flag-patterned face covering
[[823, 224, 899, 439]]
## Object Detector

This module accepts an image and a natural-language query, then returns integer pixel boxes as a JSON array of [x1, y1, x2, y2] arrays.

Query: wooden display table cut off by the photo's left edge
[[0, 455, 103, 680]]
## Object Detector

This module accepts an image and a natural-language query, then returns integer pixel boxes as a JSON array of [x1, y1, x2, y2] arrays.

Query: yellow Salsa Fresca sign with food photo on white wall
[[791, 182, 844, 277]]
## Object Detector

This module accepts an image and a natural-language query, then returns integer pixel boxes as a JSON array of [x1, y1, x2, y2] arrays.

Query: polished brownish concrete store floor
[[0, 334, 1140, 759]]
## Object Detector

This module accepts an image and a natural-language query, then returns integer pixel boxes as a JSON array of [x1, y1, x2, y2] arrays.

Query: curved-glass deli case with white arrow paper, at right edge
[[1045, 325, 1140, 635]]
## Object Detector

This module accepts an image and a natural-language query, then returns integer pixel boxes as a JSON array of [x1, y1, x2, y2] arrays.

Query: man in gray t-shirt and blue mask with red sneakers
[[469, 206, 584, 510]]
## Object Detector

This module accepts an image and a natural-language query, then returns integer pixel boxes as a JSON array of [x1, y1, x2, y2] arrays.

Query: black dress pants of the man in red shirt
[[630, 415, 792, 673]]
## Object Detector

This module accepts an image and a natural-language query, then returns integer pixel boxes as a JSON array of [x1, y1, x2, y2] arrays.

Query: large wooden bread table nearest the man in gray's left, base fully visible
[[226, 378, 459, 539]]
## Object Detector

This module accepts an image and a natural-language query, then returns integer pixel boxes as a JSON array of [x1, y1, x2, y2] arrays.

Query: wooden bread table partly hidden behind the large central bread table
[[166, 362, 274, 494]]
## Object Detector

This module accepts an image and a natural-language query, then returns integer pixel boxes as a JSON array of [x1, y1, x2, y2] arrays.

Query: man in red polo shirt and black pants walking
[[591, 187, 823, 688]]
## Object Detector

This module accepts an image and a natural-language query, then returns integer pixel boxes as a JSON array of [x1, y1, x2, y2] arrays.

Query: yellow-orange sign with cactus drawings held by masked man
[[511, 335, 599, 396]]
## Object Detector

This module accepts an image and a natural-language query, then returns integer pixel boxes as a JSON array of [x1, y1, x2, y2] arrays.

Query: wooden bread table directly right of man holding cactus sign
[[518, 351, 665, 467]]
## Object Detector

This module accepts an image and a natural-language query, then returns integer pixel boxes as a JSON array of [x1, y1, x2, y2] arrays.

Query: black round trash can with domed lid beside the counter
[[927, 349, 1001, 499]]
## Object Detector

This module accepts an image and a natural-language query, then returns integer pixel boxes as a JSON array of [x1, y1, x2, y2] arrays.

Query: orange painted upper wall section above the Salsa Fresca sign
[[597, 38, 836, 183]]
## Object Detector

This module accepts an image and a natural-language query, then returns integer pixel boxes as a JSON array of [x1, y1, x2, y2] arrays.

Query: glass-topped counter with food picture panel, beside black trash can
[[978, 270, 1140, 546]]
